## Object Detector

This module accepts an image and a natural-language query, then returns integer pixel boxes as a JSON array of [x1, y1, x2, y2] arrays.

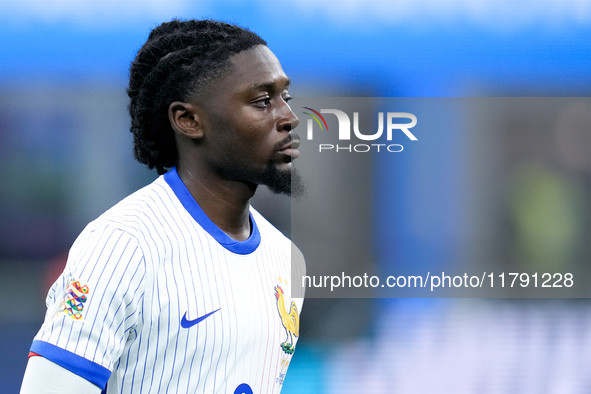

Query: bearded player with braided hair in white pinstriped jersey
[[21, 20, 303, 394]]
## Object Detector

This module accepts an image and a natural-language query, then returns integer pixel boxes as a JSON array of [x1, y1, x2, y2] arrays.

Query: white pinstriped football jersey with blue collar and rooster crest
[[31, 169, 303, 394]]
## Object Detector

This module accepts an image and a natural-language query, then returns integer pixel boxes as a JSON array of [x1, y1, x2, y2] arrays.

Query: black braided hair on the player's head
[[127, 19, 267, 174]]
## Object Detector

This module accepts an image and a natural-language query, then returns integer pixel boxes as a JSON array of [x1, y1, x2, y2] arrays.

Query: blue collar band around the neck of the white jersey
[[164, 167, 261, 254]]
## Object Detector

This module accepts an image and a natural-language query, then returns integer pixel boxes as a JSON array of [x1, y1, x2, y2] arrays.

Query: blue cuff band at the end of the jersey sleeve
[[31, 340, 111, 389]]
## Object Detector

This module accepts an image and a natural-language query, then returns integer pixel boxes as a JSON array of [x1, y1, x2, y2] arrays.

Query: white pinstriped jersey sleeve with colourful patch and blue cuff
[[31, 226, 145, 389]]
